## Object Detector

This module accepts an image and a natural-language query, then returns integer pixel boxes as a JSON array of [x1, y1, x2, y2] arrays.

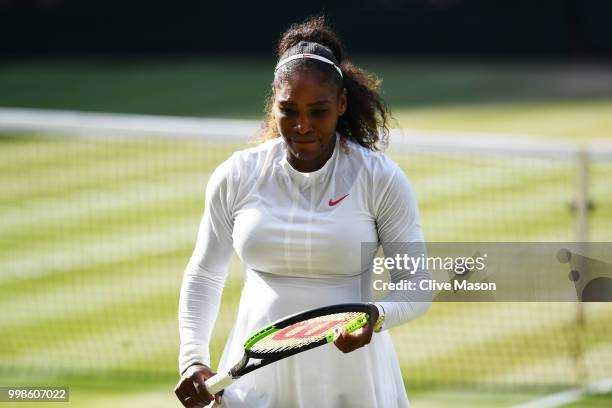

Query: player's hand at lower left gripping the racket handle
[[174, 364, 223, 408]]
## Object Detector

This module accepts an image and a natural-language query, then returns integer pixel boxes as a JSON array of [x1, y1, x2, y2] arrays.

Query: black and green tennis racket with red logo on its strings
[[205, 303, 376, 394]]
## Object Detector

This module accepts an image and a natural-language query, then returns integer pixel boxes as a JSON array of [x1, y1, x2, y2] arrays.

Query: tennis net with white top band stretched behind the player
[[0, 109, 612, 387]]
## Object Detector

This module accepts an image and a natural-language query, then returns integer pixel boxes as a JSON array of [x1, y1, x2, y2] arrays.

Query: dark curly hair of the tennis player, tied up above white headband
[[261, 16, 391, 150]]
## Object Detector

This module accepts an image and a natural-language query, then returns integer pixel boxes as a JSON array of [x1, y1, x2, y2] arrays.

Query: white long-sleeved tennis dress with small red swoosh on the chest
[[179, 135, 430, 408]]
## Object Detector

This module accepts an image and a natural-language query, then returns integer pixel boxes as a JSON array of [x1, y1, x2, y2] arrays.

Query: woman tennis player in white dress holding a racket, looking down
[[175, 17, 431, 408]]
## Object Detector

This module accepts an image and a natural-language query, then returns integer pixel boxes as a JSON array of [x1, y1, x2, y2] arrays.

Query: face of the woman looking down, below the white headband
[[273, 72, 346, 172]]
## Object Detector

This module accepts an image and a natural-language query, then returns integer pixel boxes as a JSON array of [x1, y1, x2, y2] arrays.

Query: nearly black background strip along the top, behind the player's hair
[[0, 0, 612, 59]]
